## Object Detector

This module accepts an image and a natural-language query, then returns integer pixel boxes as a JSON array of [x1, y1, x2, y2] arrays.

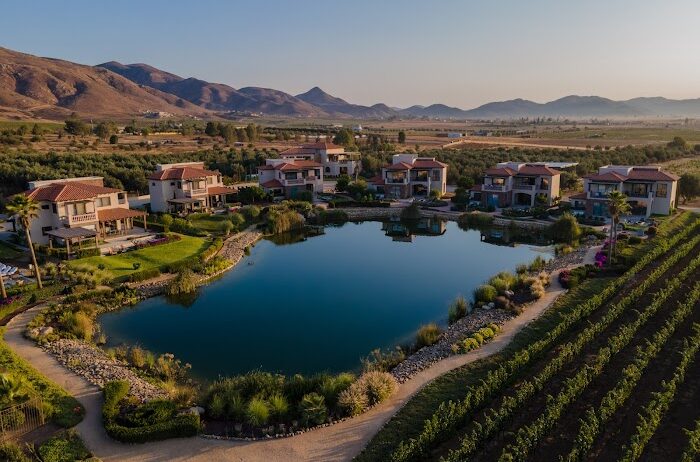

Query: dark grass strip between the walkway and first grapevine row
[[355, 278, 613, 462]]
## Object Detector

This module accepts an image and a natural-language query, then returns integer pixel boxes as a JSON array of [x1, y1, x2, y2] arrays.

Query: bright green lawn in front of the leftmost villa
[[69, 235, 209, 278]]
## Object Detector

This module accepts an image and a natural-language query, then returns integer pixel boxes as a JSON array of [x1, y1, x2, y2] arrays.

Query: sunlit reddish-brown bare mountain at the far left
[[0, 47, 207, 119]]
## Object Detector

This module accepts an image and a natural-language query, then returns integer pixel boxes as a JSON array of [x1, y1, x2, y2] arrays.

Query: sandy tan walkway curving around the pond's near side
[[5, 272, 564, 462]]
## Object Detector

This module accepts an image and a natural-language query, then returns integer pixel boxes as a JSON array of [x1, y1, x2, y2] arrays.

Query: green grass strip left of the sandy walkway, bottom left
[[0, 328, 84, 428]]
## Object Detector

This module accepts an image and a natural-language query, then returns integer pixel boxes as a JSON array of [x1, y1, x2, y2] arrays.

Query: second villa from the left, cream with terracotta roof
[[148, 162, 236, 213]]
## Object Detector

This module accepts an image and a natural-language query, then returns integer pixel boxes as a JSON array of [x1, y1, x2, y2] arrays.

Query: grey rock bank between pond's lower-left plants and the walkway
[[41, 339, 167, 402]]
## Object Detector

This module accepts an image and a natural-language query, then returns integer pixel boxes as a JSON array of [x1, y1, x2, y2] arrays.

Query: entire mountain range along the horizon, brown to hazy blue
[[0, 47, 700, 120]]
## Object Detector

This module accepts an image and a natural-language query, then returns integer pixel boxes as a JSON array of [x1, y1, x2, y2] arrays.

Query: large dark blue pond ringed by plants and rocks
[[100, 220, 551, 379]]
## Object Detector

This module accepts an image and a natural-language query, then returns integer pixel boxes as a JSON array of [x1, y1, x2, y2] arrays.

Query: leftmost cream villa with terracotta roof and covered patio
[[24, 177, 145, 245]]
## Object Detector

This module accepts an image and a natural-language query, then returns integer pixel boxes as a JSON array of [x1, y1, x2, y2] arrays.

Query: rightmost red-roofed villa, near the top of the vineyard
[[569, 165, 678, 217]]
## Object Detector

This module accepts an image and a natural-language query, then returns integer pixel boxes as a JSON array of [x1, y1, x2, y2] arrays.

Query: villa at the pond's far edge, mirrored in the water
[[368, 154, 447, 199]]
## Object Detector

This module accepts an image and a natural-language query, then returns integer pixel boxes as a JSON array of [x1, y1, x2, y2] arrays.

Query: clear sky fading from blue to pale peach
[[0, 0, 700, 109]]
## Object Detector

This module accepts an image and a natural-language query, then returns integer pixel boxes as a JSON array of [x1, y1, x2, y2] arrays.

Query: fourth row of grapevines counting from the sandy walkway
[[565, 282, 700, 462]]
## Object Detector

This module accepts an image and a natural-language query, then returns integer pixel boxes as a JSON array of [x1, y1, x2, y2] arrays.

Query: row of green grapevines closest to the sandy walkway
[[391, 220, 700, 462]]
